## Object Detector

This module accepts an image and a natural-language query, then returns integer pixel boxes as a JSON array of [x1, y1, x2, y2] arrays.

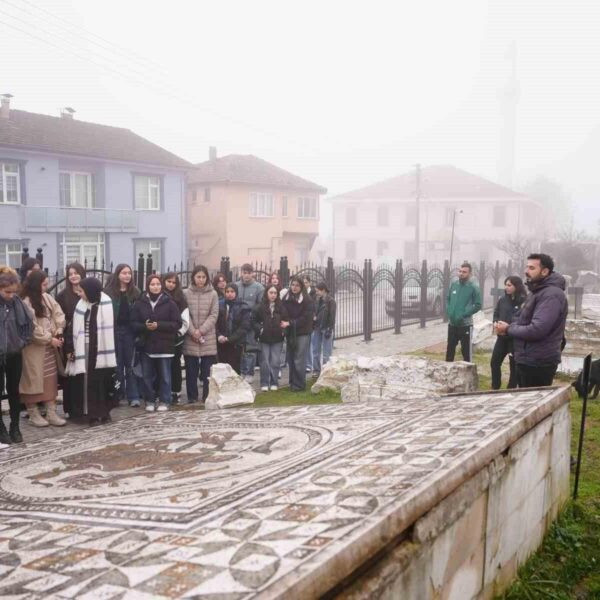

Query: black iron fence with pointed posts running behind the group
[[11, 248, 583, 341]]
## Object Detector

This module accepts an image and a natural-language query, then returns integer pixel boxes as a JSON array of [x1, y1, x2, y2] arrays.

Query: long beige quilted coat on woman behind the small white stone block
[[183, 283, 219, 356]]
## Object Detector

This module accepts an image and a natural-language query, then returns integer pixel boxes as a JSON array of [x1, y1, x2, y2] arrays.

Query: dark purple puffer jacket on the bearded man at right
[[507, 273, 568, 367]]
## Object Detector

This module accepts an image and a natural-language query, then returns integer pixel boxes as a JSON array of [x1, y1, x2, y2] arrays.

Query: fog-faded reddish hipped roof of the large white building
[[335, 165, 524, 200]]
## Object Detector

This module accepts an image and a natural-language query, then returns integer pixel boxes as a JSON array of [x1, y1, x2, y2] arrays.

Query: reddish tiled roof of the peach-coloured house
[[188, 154, 327, 194]]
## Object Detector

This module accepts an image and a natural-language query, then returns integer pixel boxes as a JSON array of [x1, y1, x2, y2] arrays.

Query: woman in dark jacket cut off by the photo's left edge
[[0, 266, 33, 444]]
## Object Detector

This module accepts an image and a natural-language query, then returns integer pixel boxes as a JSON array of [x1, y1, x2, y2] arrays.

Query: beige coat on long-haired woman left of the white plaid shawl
[[19, 294, 65, 394]]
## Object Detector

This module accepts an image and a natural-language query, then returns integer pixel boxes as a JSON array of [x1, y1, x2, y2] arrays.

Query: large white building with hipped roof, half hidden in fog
[[329, 166, 547, 263]]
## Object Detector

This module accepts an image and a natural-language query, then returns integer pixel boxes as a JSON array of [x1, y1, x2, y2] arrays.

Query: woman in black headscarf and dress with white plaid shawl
[[66, 277, 117, 425]]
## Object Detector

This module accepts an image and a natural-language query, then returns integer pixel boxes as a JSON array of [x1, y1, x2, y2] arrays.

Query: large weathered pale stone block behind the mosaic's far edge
[[312, 355, 478, 403]]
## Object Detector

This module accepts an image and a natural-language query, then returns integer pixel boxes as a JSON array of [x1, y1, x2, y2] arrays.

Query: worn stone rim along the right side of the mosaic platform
[[256, 387, 570, 599]]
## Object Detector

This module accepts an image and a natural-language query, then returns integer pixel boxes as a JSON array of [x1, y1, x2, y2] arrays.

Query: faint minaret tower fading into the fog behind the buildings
[[497, 41, 519, 187]]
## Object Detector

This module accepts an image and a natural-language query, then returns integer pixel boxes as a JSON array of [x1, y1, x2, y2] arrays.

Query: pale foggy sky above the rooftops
[[0, 0, 600, 233]]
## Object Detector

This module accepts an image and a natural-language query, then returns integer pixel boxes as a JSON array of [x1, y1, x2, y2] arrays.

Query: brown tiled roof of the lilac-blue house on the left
[[0, 109, 190, 169]]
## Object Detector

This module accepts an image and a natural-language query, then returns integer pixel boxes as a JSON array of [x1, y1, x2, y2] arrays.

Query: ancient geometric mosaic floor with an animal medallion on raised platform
[[0, 390, 557, 600]]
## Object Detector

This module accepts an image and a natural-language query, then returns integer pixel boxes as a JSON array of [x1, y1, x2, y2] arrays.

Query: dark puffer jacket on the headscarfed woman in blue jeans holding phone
[[131, 294, 181, 354]]
